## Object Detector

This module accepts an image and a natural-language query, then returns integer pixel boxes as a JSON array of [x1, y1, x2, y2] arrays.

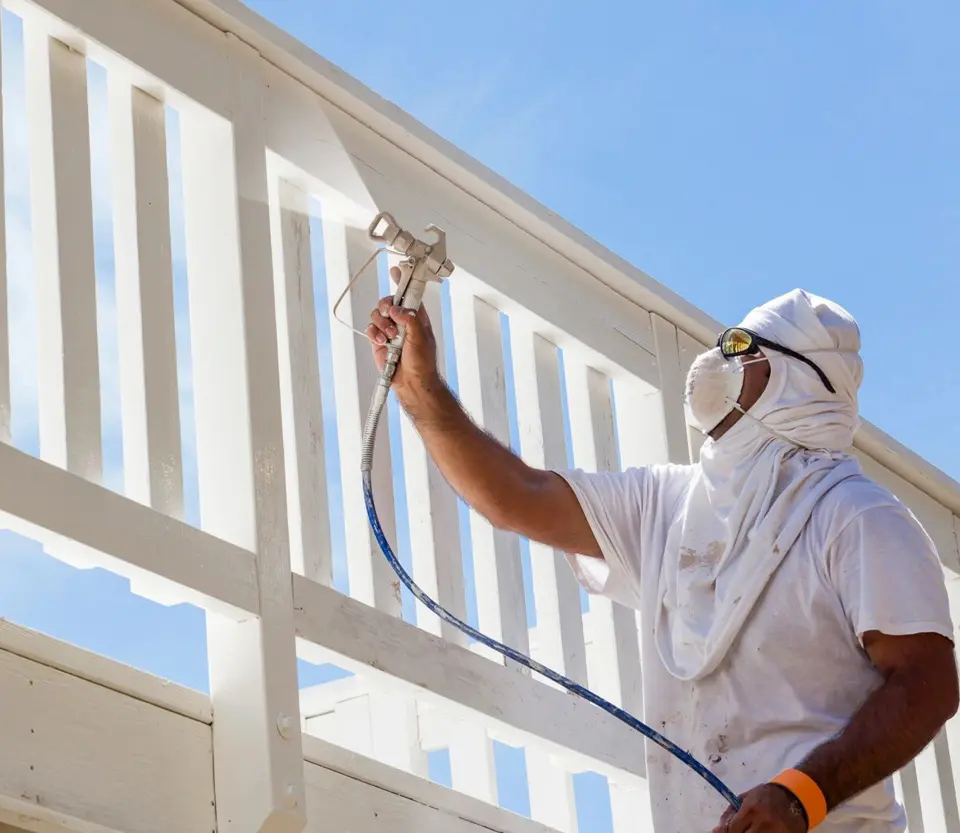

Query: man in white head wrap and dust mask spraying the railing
[[368, 282, 958, 833]]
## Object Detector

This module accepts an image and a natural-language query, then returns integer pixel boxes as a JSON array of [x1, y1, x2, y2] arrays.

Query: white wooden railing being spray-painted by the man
[[0, 0, 960, 833]]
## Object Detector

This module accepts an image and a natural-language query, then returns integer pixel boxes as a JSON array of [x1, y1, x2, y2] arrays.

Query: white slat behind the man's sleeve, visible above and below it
[[564, 358, 643, 715]]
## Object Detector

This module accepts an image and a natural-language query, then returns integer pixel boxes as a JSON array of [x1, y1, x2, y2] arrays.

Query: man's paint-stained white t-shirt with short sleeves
[[559, 466, 953, 833]]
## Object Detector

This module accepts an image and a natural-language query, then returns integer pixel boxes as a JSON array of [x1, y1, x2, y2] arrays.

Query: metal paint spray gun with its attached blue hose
[[334, 212, 740, 810]]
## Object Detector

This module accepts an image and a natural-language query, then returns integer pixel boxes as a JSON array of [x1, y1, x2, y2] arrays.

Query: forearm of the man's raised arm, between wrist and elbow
[[398, 376, 533, 526]]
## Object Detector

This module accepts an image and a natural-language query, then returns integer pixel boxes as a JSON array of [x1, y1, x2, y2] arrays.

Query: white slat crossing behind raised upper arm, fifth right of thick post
[[510, 319, 587, 683]]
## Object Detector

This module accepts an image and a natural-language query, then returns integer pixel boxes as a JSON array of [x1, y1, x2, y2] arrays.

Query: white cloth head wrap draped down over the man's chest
[[654, 290, 863, 680]]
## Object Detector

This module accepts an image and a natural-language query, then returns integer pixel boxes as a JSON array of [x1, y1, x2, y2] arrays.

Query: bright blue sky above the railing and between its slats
[[0, 0, 960, 833]]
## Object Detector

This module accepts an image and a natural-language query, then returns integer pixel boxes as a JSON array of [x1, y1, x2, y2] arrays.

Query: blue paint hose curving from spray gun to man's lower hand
[[362, 374, 740, 810]]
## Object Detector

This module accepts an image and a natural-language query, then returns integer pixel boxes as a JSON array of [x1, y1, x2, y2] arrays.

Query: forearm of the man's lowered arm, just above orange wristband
[[797, 674, 949, 810]]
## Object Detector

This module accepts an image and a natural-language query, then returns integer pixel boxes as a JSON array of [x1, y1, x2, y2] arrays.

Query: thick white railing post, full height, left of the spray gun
[[181, 37, 306, 833]]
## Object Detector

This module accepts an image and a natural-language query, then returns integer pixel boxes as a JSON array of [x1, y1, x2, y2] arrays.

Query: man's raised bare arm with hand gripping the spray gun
[[368, 290, 601, 558]]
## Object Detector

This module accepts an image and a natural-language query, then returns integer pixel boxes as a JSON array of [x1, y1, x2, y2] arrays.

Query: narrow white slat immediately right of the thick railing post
[[270, 176, 333, 586]]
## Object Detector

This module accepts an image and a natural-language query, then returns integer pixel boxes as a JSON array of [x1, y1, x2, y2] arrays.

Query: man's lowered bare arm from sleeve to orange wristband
[[797, 631, 958, 809]]
